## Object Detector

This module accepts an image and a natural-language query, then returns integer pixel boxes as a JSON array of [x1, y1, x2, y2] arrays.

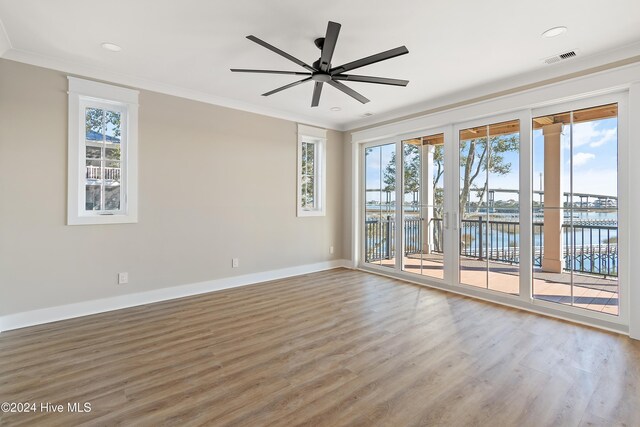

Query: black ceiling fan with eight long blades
[[231, 21, 409, 107]]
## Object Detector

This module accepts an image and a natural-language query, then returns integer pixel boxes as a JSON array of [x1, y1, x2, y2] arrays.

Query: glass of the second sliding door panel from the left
[[402, 134, 444, 279]]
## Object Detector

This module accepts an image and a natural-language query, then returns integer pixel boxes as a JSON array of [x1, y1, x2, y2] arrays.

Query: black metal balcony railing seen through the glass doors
[[365, 216, 618, 277]]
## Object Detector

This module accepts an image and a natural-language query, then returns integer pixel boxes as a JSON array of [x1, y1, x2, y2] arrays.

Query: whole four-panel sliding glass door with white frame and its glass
[[361, 95, 628, 321]]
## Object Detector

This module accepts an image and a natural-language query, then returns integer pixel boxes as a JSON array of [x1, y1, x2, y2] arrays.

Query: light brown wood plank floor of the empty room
[[0, 269, 640, 427]]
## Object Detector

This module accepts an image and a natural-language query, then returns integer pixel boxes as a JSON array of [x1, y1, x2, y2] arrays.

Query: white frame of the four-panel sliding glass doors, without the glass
[[357, 97, 630, 325]]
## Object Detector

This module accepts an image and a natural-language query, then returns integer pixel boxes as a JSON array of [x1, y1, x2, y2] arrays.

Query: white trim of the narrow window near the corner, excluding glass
[[297, 124, 327, 217]]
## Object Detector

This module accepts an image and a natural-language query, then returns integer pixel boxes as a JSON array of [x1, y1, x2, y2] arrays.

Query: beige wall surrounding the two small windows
[[0, 60, 348, 315]]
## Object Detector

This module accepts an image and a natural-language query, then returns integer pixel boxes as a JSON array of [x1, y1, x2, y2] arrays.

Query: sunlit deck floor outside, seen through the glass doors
[[375, 254, 619, 316]]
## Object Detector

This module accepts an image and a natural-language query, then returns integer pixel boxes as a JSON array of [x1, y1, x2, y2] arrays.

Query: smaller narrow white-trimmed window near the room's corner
[[298, 125, 327, 216]]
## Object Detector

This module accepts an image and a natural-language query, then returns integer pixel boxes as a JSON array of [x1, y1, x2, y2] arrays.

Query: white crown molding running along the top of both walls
[[0, 39, 640, 132]]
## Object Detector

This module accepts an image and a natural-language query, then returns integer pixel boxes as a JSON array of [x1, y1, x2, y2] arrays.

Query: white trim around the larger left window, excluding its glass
[[67, 77, 139, 225]]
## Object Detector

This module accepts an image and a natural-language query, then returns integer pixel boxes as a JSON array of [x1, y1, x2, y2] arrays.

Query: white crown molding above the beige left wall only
[[0, 48, 344, 130]]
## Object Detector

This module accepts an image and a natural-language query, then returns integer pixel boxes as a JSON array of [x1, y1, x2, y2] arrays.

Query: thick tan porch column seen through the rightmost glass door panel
[[542, 123, 564, 273]]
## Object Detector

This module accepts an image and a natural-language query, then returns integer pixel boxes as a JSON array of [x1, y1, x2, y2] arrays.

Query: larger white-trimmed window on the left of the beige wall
[[67, 77, 138, 225]]
